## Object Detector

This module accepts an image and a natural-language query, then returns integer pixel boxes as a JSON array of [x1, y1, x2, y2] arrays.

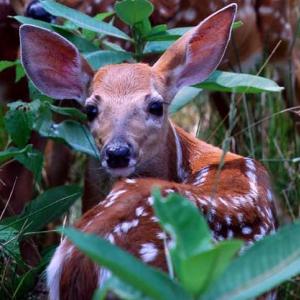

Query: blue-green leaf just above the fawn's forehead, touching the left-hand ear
[[85, 50, 133, 70]]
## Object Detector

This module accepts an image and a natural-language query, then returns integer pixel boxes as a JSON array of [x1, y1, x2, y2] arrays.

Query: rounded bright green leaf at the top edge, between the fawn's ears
[[115, 0, 154, 26]]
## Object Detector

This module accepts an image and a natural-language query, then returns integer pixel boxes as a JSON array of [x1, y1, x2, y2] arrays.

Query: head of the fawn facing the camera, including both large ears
[[20, 4, 236, 176]]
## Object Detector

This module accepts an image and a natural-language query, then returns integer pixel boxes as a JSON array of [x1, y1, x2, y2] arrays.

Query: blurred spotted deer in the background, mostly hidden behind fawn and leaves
[[4, 0, 300, 219]]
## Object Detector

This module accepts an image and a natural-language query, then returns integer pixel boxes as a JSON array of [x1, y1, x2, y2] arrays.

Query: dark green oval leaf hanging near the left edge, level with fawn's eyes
[[5, 109, 34, 147]]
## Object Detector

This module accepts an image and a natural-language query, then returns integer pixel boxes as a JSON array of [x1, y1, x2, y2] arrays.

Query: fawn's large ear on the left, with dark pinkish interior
[[20, 25, 93, 103]]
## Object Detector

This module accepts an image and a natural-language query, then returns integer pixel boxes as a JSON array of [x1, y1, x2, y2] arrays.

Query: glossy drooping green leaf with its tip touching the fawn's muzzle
[[38, 120, 99, 158]]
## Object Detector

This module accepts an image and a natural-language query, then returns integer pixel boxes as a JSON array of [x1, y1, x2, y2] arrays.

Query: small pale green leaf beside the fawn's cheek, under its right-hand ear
[[169, 86, 202, 114]]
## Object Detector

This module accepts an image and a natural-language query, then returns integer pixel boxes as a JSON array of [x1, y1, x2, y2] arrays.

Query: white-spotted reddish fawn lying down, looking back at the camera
[[20, 4, 277, 300]]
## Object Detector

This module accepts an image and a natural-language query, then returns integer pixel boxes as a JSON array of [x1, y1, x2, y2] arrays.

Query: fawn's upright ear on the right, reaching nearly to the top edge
[[153, 4, 237, 93]]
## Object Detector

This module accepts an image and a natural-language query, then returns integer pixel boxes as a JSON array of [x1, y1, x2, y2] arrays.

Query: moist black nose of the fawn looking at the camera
[[105, 144, 131, 169]]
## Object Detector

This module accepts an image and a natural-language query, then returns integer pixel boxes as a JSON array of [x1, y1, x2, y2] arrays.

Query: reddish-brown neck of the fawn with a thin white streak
[[134, 122, 239, 182]]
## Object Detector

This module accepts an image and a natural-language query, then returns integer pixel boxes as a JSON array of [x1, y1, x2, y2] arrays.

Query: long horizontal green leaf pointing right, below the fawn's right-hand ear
[[195, 71, 283, 94]]
